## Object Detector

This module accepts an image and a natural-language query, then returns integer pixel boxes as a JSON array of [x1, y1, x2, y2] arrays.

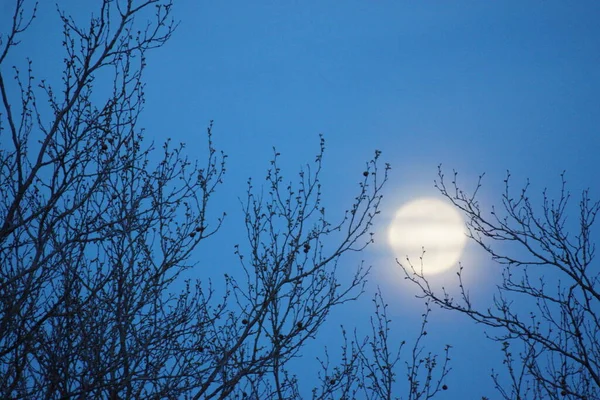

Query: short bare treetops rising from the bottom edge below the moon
[[313, 290, 451, 400]]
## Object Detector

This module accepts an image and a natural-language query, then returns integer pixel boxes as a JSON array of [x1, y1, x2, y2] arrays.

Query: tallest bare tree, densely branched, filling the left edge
[[0, 0, 224, 398]]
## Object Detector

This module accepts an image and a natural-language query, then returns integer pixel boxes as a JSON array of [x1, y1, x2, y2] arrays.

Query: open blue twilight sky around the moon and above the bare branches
[[7, 0, 600, 399]]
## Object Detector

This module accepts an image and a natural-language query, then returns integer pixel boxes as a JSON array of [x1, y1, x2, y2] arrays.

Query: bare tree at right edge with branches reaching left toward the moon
[[404, 168, 600, 400]]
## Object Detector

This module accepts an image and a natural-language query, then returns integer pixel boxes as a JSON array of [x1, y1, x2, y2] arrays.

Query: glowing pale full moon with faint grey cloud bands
[[388, 198, 467, 275]]
